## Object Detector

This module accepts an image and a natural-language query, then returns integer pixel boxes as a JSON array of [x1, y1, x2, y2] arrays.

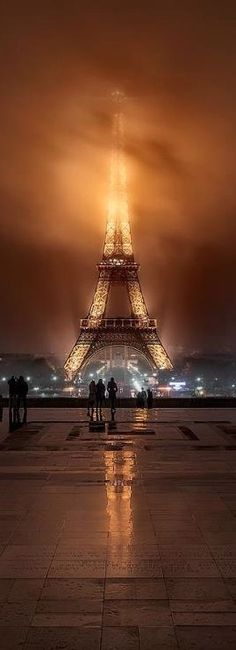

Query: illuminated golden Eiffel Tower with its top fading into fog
[[64, 91, 172, 380]]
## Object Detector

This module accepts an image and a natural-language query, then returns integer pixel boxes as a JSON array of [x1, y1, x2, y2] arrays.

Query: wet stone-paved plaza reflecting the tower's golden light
[[0, 409, 236, 650]]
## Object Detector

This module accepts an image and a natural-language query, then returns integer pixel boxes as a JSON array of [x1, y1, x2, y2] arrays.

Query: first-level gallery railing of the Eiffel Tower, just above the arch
[[80, 318, 157, 329]]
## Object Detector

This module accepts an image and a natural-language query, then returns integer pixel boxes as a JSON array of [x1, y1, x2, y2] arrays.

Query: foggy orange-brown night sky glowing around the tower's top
[[0, 0, 236, 360]]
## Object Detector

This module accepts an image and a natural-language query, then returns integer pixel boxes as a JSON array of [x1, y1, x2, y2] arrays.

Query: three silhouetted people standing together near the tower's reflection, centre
[[88, 377, 118, 419]]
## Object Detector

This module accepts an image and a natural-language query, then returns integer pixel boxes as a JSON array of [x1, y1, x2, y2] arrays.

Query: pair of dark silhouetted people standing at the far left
[[8, 375, 28, 425]]
